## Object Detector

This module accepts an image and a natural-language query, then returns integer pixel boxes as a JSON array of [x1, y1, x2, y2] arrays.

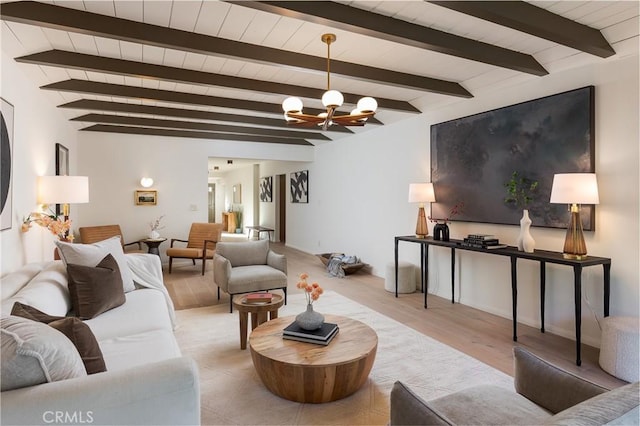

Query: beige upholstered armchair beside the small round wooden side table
[[213, 240, 287, 312]]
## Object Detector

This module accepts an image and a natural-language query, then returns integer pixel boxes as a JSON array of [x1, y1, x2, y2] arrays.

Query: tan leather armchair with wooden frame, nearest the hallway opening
[[167, 223, 222, 275]]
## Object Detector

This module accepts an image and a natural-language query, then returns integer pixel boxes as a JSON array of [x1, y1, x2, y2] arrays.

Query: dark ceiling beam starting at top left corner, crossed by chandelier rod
[[0, 1, 473, 98]]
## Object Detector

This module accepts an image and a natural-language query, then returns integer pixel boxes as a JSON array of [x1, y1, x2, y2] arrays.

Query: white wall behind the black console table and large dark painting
[[287, 56, 640, 346]]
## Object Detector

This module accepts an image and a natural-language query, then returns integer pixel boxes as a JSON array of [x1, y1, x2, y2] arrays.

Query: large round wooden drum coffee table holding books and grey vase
[[249, 315, 378, 403]]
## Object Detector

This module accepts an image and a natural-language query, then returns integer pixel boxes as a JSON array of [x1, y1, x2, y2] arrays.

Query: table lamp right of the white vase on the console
[[549, 173, 599, 260]]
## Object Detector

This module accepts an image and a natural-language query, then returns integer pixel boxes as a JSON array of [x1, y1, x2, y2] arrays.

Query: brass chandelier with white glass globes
[[282, 34, 378, 130]]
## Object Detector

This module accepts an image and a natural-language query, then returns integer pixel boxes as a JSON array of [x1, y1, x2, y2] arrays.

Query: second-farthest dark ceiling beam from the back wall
[[71, 114, 331, 141]]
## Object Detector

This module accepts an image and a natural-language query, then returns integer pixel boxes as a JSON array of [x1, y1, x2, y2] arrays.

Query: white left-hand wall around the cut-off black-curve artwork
[[0, 52, 78, 275]]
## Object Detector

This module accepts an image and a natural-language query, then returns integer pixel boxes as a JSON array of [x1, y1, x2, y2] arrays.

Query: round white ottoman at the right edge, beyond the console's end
[[599, 317, 640, 382]]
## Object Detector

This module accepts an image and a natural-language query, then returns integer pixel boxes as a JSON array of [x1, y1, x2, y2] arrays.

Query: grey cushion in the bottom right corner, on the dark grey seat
[[545, 382, 640, 425]]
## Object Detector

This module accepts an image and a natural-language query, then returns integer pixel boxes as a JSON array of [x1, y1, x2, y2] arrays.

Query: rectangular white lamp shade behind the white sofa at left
[[38, 176, 89, 204]]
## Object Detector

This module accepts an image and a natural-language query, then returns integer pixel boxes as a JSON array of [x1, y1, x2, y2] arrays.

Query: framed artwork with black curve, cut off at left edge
[[0, 98, 13, 230]]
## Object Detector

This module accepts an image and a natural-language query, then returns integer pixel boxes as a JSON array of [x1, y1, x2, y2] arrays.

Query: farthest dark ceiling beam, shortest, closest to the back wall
[[80, 124, 313, 146]]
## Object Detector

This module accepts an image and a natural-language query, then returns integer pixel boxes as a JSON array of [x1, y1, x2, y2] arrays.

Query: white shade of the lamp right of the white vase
[[549, 173, 600, 204]]
